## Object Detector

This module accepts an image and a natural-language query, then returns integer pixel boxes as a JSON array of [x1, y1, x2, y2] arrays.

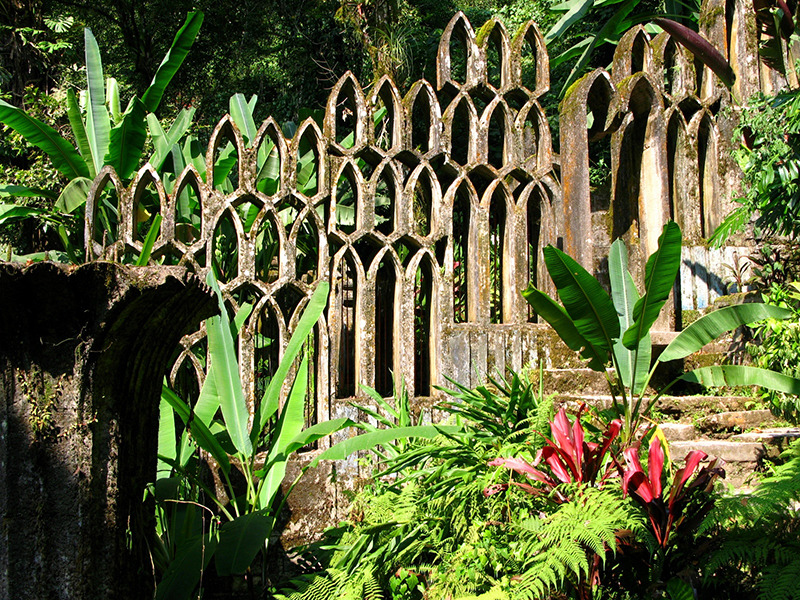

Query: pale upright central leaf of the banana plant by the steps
[[608, 239, 652, 394]]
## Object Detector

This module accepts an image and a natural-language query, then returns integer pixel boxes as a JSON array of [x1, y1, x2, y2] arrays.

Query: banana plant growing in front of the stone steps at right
[[522, 221, 800, 443]]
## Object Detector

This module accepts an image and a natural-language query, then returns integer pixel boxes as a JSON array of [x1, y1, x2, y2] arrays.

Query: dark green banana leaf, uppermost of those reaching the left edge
[[0, 100, 90, 179]]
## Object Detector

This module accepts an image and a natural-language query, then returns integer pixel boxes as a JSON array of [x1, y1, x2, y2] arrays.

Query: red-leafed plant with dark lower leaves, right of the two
[[622, 436, 725, 548]]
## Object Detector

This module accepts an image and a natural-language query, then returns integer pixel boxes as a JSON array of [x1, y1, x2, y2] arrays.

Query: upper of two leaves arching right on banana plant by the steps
[[658, 303, 793, 362]]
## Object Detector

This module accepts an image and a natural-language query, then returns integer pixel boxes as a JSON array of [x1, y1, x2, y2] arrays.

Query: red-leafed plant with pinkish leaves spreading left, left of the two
[[483, 406, 622, 503]]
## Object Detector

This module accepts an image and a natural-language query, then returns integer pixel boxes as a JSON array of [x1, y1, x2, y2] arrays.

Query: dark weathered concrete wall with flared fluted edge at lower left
[[0, 262, 215, 600]]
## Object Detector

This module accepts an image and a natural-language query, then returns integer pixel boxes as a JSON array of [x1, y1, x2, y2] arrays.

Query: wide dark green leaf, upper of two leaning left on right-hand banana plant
[[543, 246, 619, 352]]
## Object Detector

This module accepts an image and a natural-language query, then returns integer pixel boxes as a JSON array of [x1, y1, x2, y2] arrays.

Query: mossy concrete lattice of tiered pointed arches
[[86, 4, 752, 432]]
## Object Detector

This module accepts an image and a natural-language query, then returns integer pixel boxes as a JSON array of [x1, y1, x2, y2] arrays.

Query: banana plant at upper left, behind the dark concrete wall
[[0, 11, 203, 261]]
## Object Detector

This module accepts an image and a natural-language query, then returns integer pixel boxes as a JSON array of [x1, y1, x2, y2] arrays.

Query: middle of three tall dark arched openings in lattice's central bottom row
[[375, 253, 395, 396]]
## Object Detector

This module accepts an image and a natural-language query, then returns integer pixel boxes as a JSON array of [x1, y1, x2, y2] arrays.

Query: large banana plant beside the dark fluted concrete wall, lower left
[[151, 271, 446, 599]]
